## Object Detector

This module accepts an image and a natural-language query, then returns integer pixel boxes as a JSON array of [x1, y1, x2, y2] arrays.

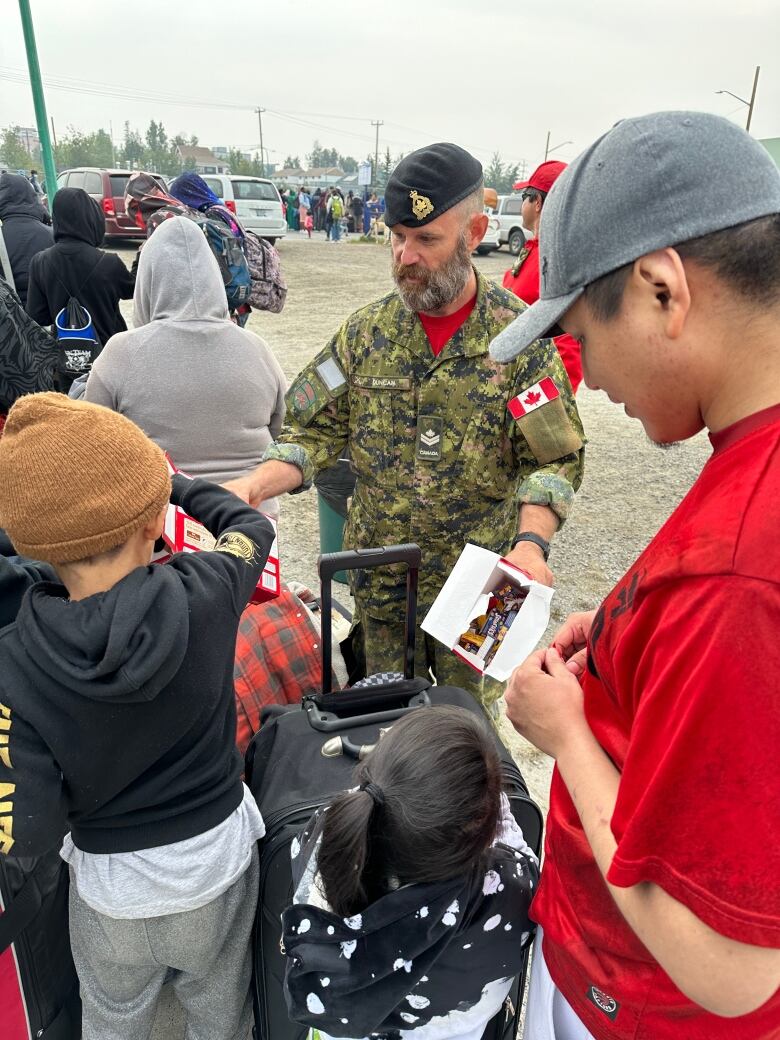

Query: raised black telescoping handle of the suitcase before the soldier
[[317, 543, 422, 694]]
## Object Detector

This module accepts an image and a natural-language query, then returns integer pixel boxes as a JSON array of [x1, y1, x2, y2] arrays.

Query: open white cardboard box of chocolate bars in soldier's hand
[[420, 543, 553, 682]]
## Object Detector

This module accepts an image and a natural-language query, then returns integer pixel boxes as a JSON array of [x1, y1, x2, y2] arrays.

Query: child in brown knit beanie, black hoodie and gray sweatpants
[[0, 393, 274, 1040]]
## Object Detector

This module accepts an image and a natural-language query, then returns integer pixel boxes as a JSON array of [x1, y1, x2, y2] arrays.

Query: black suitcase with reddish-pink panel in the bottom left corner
[[0, 852, 81, 1040]]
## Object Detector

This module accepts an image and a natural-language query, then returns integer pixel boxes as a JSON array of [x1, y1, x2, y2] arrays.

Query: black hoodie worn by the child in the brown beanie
[[0, 475, 274, 856]]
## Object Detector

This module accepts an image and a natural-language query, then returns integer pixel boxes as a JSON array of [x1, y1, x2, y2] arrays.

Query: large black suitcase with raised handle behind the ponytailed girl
[[246, 545, 542, 1040]]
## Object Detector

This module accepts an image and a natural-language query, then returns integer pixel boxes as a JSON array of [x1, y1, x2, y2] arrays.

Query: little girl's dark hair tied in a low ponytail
[[318, 706, 501, 917]]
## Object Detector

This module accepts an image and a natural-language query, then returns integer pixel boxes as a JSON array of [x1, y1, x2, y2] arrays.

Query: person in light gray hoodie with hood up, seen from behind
[[85, 216, 287, 517]]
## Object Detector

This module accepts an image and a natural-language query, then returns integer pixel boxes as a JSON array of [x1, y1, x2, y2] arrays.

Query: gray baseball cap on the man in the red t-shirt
[[490, 112, 780, 361]]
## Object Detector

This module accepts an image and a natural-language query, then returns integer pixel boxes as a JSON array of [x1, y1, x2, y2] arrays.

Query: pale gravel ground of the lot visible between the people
[[112, 233, 709, 1040]]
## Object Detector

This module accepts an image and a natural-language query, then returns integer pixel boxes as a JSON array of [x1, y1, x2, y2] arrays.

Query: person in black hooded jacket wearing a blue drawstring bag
[[27, 188, 135, 346]]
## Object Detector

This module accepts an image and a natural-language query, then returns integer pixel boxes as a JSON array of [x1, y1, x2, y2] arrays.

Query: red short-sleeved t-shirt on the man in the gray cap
[[531, 405, 780, 1040]]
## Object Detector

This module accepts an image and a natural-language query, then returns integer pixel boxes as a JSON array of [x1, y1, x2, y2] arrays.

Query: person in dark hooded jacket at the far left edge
[[0, 174, 54, 306]]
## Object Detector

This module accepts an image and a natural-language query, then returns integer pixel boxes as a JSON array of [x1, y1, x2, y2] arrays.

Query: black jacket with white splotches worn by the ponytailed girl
[[282, 796, 539, 1040]]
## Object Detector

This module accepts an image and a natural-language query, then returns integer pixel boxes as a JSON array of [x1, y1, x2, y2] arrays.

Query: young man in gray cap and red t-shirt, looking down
[[491, 112, 780, 1040]]
